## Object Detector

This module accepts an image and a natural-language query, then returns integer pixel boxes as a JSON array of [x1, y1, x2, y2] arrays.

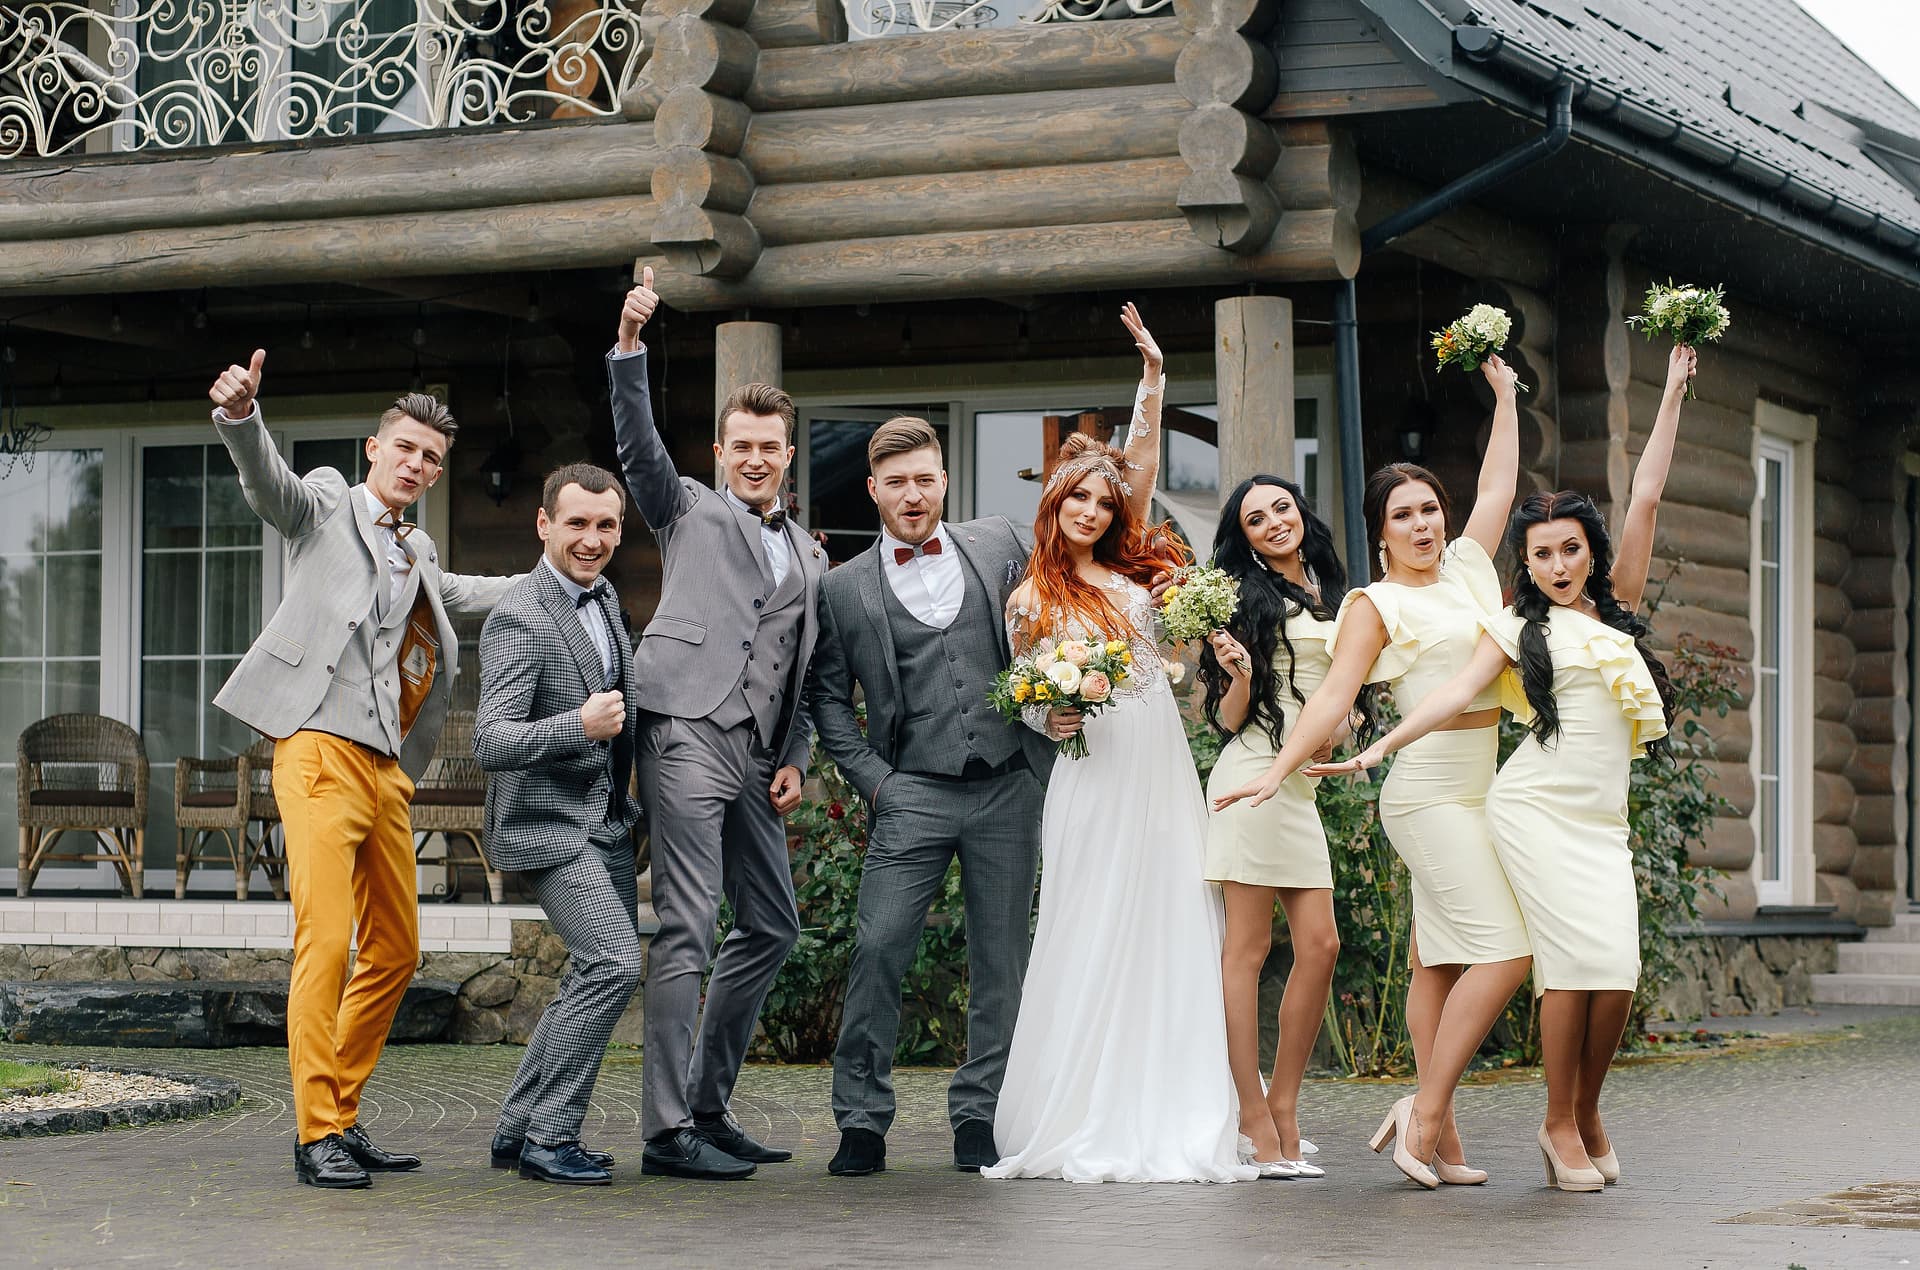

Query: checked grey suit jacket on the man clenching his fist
[[474, 567, 639, 868]]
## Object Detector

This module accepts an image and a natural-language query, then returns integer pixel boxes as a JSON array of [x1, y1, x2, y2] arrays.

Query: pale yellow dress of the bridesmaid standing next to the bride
[[1206, 603, 1332, 890]]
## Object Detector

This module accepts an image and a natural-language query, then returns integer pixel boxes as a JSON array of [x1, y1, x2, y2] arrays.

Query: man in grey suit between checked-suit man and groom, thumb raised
[[607, 269, 826, 1178]]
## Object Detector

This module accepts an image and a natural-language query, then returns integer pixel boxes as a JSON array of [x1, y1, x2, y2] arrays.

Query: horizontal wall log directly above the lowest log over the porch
[[744, 158, 1187, 246]]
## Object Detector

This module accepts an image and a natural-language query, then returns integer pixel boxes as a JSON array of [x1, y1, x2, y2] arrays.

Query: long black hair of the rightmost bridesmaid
[[1507, 490, 1674, 757]]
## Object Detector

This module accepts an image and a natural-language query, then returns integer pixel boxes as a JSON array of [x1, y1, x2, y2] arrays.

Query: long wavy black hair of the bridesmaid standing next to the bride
[[1200, 475, 1373, 745]]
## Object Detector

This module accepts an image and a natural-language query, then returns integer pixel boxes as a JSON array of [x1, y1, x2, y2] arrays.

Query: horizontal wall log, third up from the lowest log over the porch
[[741, 86, 1190, 184]]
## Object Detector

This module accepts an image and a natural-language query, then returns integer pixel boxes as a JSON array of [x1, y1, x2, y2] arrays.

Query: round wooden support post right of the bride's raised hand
[[1213, 296, 1298, 496]]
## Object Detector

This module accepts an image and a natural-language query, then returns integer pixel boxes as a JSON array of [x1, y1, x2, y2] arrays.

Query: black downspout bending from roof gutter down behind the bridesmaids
[[1332, 79, 1572, 582]]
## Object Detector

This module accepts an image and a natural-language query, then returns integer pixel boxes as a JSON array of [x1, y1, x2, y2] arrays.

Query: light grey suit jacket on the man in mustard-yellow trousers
[[213, 402, 515, 780]]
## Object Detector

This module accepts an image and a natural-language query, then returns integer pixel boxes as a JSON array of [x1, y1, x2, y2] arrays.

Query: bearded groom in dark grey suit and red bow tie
[[810, 417, 1054, 1178]]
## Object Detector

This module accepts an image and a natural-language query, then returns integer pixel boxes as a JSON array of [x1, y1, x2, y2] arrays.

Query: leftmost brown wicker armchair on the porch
[[17, 715, 148, 899]]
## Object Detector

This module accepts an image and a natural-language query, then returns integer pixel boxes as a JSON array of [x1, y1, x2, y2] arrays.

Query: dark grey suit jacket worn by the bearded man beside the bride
[[808, 517, 1054, 805]]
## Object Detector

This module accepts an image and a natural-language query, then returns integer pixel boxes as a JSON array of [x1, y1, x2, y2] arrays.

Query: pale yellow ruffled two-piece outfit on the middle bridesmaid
[[1327, 538, 1530, 966]]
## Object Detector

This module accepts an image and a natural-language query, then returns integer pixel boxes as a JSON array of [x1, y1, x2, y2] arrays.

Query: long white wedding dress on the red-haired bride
[[983, 580, 1256, 1182]]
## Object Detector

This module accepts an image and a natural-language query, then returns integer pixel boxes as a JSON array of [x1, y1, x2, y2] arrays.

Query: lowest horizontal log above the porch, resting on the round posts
[[641, 211, 1357, 309]]
